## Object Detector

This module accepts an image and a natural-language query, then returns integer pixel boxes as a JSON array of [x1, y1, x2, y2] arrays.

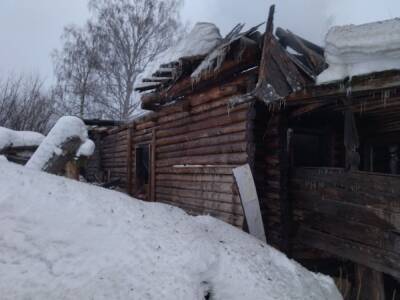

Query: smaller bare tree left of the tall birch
[[53, 23, 101, 118]]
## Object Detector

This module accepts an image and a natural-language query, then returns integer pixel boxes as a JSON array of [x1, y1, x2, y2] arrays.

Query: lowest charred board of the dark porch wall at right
[[296, 227, 400, 279]]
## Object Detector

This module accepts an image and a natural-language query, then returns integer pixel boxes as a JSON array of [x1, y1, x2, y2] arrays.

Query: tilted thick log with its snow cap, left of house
[[26, 117, 94, 174]]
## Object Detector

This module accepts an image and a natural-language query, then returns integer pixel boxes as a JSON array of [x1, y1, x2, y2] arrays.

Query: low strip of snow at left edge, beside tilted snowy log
[[0, 127, 44, 151]]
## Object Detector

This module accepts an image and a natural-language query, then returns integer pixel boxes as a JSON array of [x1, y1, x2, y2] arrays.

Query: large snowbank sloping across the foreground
[[0, 161, 341, 300]]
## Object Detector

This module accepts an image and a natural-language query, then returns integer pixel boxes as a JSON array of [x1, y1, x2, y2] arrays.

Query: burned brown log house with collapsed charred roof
[[88, 9, 400, 299]]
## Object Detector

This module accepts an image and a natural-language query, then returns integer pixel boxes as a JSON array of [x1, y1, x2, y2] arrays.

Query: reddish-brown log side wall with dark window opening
[[86, 75, 254, 227]]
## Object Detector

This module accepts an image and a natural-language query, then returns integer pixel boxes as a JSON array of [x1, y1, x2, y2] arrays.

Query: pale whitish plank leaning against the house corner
[[233, 164, 267, 243]]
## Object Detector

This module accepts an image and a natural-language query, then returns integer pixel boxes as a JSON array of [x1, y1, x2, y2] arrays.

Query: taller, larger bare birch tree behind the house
[[89, 0, 182, 120]]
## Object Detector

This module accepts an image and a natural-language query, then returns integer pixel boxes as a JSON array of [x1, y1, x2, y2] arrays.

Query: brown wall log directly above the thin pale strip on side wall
[[156, 153, 248, 167]]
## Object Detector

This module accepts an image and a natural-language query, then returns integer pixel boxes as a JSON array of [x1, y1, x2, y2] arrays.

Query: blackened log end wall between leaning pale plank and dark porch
[[248, 103, 286, 250]]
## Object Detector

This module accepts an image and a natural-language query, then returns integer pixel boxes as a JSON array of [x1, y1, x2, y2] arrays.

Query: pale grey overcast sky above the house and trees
[[0, 0, 400, 81]]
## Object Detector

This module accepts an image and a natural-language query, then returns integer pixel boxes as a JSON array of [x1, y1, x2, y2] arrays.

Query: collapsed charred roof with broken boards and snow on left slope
[[135, 7, 326, 110]]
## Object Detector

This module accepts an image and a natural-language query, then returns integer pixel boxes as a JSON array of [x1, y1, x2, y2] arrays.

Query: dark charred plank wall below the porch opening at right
[[290, 168, 400, 279]]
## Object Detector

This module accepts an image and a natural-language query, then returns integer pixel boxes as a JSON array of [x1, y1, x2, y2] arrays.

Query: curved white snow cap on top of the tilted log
[[26, 117, 94, 170]]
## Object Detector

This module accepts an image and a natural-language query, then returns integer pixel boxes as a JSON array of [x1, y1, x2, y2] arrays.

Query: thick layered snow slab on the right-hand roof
[[318, 18, 400, 83]]
